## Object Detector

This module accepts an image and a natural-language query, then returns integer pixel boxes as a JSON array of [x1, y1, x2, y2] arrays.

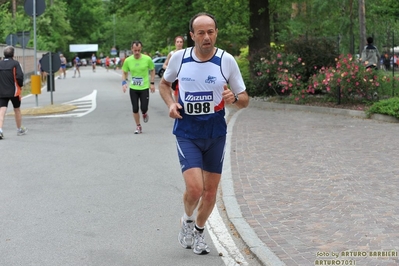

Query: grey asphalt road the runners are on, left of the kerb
[[0, 67, 257, 266]]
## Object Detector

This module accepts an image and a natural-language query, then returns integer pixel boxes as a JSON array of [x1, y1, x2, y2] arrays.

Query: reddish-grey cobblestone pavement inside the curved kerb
[[230, 101, 399, 266]]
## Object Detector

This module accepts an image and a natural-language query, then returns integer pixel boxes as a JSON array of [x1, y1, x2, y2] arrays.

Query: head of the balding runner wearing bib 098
[[190, 16, 218, 52]]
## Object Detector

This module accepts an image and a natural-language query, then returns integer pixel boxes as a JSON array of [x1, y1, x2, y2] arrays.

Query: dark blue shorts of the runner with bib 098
[[176, 136, 226, 174]]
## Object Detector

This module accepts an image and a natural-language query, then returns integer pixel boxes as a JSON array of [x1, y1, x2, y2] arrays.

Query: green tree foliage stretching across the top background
[[0, 0, 399, 65]]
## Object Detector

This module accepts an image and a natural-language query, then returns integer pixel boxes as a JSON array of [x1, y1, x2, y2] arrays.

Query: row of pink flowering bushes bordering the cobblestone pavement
[[251, 50, 399, 103]]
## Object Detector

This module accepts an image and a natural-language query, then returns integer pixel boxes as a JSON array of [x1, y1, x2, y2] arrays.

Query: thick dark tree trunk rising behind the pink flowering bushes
[[248, 0, 270, 69]]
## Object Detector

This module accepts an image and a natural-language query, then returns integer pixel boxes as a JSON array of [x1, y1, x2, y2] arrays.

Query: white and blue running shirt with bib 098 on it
[[163, 47, 246, 139]]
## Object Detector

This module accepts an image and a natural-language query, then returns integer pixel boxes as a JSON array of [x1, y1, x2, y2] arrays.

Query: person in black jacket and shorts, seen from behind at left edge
[[0, 46, 28, 139]]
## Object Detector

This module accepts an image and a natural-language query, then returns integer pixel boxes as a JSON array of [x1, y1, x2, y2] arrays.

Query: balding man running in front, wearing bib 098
[[159, 13, 249, 254]]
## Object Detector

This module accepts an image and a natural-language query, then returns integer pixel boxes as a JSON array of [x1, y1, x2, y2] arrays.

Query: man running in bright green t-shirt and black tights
[[122, 41, 155, 134]]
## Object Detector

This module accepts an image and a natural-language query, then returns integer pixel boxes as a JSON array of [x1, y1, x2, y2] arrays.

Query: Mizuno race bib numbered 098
[[184, 91, 215, 115]]
